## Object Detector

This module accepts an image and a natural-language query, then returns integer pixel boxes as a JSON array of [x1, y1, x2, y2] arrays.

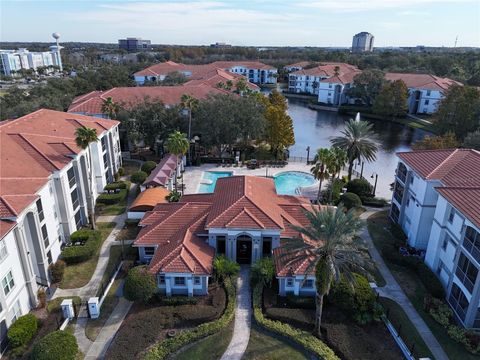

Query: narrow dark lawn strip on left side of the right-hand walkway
[[380, 298, 433, 359]]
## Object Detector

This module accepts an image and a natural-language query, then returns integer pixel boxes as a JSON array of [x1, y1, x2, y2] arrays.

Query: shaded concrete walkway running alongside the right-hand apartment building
[[360, 210, 448, 360]]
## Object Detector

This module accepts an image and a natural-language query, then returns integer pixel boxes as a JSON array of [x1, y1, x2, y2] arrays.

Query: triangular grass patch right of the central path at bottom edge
[[242, 324, 309, 360]]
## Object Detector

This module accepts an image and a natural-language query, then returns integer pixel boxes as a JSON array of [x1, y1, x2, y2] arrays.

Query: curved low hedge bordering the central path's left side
[[144, 278, 235, 360]]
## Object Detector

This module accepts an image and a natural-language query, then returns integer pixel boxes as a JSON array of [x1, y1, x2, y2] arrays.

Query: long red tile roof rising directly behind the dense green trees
[[68, 83, 230, 115]]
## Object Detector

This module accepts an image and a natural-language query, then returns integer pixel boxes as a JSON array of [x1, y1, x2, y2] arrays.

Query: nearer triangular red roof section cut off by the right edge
[[435, 186, 480, 228]]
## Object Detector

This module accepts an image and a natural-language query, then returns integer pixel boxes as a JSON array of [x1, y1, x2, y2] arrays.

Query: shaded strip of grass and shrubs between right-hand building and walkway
[[368, 212, 479, 360]]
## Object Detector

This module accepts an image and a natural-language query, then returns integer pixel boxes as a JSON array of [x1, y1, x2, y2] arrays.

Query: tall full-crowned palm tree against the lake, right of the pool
[[330, 119, 378, 181]]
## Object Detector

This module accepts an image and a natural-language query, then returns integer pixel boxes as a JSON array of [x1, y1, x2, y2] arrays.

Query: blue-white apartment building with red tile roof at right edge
[[390, 149, 480, 328]]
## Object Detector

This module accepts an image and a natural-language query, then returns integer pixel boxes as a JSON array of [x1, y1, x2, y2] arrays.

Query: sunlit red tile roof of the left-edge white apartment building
[[0, 109, 118, 237]]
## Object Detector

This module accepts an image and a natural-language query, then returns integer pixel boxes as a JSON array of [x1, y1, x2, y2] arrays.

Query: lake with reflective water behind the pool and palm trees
[[288, 99, 429, 199]]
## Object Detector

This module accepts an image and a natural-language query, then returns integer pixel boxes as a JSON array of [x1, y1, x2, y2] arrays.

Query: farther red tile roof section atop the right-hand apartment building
[[397, 149, 480, 187]]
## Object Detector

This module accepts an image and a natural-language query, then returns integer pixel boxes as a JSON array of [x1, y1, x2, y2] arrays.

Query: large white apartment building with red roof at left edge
[[0, 109, 121, 344]]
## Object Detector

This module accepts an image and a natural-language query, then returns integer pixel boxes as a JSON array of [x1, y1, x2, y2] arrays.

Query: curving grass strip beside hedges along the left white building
[[59, 222, 116, 289]]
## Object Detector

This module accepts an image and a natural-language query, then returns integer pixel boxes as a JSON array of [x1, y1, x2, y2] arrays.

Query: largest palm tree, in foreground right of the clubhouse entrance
[[282, 206, 365, 337]]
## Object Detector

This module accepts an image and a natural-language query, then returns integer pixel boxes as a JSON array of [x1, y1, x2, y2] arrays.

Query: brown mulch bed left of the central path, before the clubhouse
[[105, 284, 226, 360]]
